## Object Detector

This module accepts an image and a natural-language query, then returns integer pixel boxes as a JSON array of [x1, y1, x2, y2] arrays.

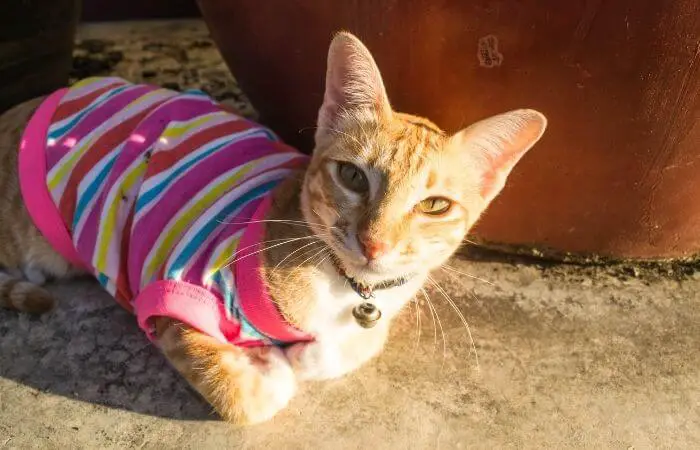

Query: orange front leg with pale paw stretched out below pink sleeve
[[156, 317, 297, 425]]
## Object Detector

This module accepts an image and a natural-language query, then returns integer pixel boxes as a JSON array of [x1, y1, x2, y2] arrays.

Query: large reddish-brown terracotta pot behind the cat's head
[[199, 0, 700, 258]]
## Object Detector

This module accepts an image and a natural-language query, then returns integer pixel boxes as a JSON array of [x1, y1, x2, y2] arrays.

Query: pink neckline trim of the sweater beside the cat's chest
[[234, 195, 313, 342]]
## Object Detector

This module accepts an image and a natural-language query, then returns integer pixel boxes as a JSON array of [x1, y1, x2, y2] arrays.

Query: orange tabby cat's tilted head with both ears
[[302, 33, 547, 283]]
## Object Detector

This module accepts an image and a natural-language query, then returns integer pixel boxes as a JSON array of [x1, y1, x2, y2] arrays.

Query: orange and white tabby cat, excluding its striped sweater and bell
[[0, 33, 546, 423]]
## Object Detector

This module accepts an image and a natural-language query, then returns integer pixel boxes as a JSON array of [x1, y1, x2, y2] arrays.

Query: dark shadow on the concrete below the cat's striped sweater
[[0, 280, 216, 420]]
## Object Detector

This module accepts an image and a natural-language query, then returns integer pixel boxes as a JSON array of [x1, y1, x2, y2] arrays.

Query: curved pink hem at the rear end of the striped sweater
[[19, 89, 85, 267]]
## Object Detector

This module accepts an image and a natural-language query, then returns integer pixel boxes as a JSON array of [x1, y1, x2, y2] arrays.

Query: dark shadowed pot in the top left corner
[[0, 0, 80, 111]]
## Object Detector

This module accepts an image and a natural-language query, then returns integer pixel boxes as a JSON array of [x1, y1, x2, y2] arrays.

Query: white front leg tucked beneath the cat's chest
[[286, 324, 389, 380]]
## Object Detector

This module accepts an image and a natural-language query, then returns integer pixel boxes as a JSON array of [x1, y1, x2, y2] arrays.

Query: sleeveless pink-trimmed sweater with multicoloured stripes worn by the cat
[[19, 78, 307, 346]]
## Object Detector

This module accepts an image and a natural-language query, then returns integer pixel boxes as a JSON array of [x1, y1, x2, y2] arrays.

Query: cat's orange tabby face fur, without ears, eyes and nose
[[302, 110, 482, 283]]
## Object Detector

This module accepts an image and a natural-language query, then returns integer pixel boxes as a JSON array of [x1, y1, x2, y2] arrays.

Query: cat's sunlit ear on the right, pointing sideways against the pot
[[450, 109, 547, 205]]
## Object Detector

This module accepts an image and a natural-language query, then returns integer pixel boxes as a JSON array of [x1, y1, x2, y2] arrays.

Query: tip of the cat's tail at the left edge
[[0, 272, 55, 314]]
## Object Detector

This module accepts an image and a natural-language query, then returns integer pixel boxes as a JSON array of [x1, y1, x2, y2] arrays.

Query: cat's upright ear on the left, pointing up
[[316, 32, 391, 143]]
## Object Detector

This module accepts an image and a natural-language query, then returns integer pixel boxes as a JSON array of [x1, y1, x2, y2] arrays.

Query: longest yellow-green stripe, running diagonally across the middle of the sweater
[[142, 164, 252, 280]]
